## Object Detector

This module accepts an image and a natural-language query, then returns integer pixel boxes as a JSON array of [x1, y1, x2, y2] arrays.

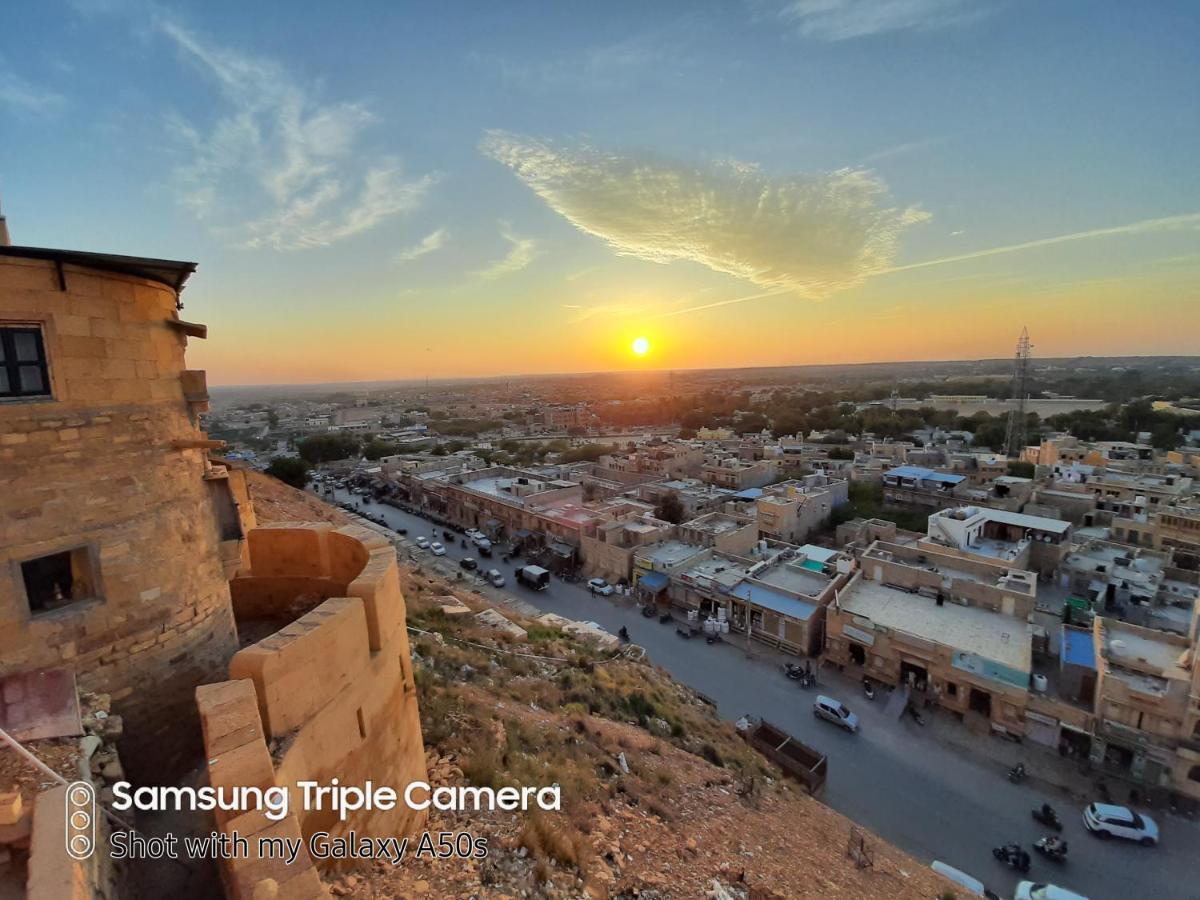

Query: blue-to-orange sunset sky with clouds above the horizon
[[0, 0, 1200, 384]]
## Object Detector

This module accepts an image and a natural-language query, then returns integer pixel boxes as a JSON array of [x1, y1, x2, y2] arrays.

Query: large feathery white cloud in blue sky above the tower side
[[155, 18, 438, 250]]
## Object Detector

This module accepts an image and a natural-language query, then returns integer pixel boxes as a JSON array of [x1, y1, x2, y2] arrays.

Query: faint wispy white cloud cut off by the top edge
[[750, 0, 994, 41]]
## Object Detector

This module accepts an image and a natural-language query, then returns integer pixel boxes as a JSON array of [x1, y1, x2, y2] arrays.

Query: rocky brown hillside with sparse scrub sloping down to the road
[[241, 473, 953, 900]]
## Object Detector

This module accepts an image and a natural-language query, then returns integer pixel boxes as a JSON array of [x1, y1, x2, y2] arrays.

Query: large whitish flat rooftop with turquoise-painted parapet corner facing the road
[[839, 577, 1033, 672]]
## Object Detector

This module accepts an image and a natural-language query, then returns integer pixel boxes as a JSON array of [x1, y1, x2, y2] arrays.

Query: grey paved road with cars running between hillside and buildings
[[338, 492, 1200, 900]]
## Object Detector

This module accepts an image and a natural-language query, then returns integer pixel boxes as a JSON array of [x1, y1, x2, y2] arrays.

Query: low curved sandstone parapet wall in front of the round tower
[[204, 523, 425, 898]]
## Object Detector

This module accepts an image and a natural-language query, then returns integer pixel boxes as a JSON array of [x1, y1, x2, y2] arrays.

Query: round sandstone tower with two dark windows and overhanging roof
[[0, 222, 242, 782]]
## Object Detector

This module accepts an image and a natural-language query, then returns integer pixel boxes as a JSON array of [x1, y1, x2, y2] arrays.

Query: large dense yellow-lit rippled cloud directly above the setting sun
[[481, 132, 928, 298]]
